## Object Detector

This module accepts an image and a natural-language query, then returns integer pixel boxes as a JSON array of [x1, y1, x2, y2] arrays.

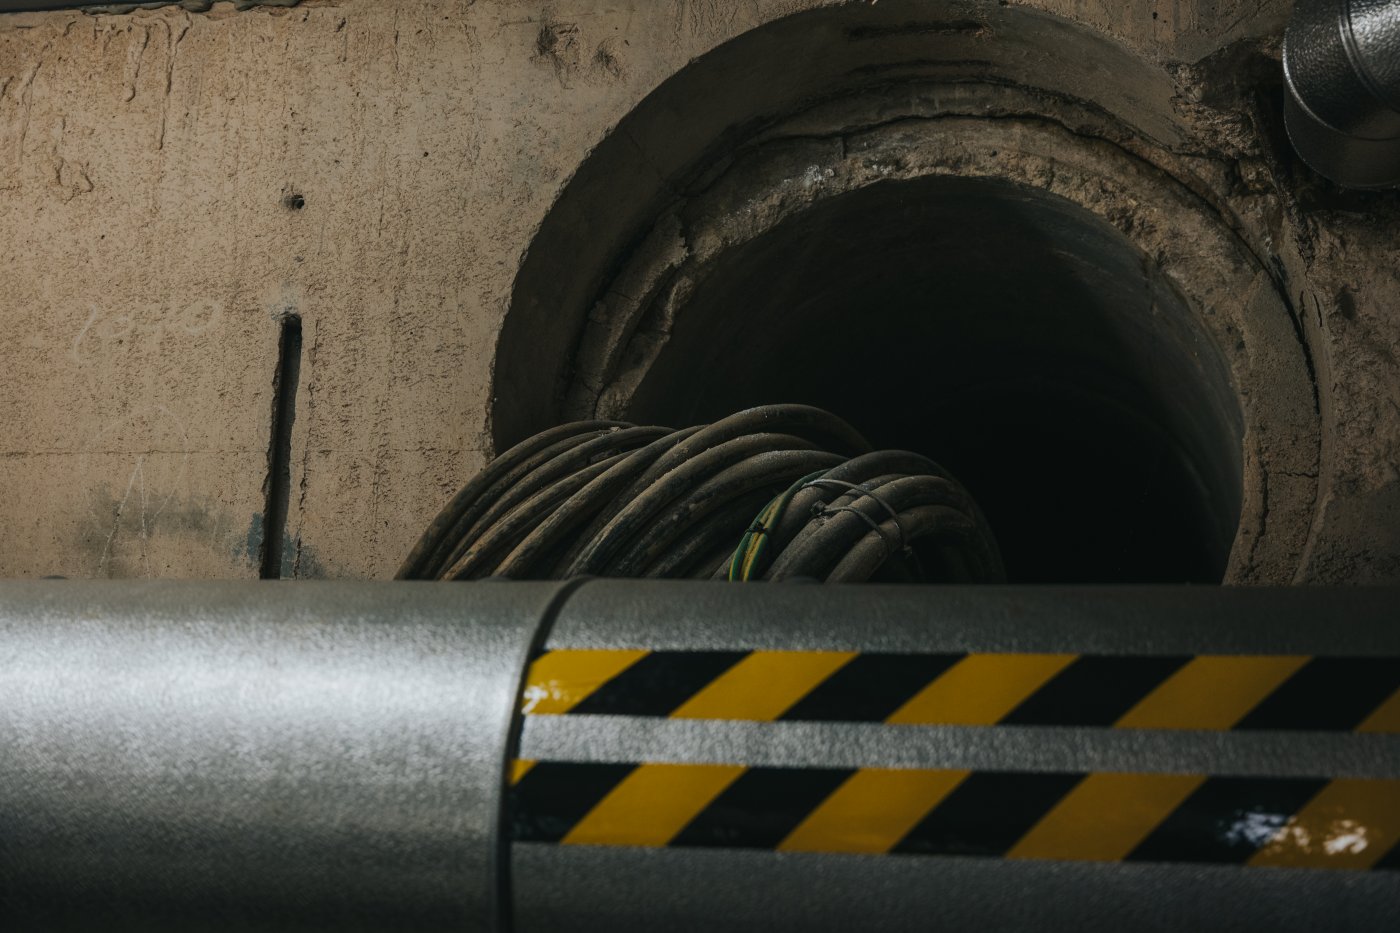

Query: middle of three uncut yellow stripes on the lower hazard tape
[[778, 768, 969, 853]]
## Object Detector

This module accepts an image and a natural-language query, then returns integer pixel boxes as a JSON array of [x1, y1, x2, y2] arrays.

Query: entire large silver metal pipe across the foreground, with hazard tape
[[0, 581, 1400, 932]]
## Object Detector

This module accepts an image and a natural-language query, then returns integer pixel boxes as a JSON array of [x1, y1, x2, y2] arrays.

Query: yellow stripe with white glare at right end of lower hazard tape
[[1249, 779, 1400, 870]]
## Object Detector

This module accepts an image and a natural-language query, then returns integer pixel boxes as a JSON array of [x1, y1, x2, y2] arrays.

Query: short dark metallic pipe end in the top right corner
[[1284, 0, 1400, 188]]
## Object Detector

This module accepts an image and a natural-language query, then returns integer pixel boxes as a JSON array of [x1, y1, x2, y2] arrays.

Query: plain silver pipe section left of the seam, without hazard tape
[[0, 583, 564, 930]]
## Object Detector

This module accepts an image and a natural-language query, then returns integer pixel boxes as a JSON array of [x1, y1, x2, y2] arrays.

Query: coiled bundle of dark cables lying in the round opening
[[398, 405, 1004, 583]]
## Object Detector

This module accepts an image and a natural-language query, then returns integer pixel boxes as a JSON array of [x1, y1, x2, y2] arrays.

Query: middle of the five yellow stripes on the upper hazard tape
[[885, 654, 1077, 726]]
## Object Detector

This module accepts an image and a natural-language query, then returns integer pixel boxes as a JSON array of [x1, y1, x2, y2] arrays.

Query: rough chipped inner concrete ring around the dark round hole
[[493, 3, 1320, 583]]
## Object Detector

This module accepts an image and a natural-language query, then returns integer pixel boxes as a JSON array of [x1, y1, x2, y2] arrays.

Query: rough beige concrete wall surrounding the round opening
[[0, 0, 1400, 580]]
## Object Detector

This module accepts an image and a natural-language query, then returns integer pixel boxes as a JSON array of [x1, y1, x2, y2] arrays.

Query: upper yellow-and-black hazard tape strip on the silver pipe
[[522, 649, 1400, 733]]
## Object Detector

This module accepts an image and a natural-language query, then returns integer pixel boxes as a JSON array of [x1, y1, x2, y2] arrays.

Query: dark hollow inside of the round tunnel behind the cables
[[627, 177, 1243, 583]]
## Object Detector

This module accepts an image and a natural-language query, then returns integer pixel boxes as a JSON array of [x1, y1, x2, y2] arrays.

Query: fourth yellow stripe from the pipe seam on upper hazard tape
[[1114, 654, 1309, 730]]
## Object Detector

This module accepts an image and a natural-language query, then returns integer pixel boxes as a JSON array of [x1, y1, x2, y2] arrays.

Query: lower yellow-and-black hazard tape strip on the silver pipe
[[510, 762, 1400, 871]]
